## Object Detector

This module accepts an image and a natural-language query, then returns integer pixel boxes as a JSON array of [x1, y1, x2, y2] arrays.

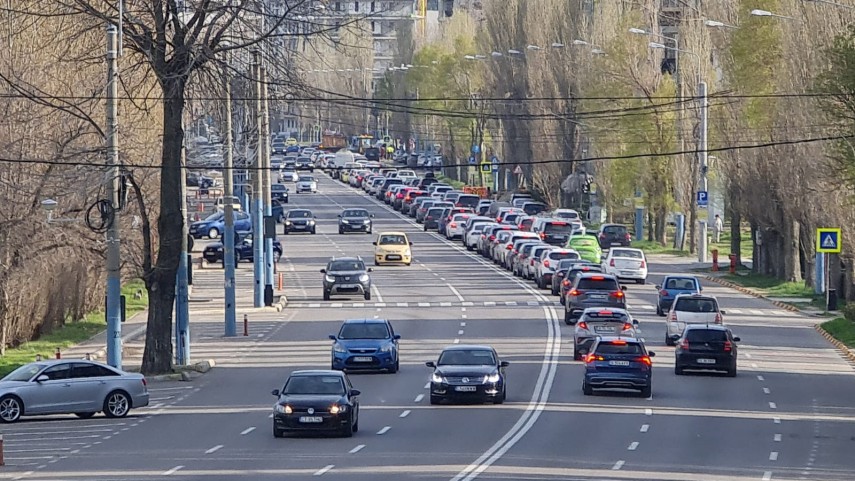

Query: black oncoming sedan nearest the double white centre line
[[425, 344, 510, 404]]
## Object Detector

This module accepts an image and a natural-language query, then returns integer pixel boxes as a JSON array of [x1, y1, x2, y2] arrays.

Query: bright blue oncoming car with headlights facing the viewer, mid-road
[[330, 319, 401, 373]]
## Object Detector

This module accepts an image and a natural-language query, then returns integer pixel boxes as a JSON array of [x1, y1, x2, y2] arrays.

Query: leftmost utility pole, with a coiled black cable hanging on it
[[106, 25, 122, 369]]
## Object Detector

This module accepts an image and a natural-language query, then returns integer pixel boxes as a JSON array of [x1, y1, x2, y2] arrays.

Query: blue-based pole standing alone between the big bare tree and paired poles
[[223, 54, 237, 337]]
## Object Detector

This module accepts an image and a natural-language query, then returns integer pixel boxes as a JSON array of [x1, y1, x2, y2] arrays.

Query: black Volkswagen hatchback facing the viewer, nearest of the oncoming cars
[[272, 370, 361, 438]]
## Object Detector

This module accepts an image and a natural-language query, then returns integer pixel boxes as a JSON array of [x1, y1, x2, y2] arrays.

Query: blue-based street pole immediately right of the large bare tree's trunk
[[175, 122, 190, 366]]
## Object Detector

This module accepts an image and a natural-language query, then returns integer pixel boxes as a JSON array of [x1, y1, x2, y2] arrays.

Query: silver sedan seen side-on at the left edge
[[0, 360, 149, 423]]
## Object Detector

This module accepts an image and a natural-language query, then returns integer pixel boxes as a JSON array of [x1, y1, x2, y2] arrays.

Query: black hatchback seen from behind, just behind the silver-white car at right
[[674, 324, 740, 377]]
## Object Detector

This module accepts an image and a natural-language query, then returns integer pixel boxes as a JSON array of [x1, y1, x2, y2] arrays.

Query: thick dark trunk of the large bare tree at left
[[142, 77, 185, 375]]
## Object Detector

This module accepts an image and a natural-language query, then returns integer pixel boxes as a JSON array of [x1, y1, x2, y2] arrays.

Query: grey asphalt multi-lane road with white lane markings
[[0, 175, 855, 481]]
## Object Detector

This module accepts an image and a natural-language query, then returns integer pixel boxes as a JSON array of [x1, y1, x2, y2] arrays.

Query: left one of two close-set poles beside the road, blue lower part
[[252, 50, 264, 307]]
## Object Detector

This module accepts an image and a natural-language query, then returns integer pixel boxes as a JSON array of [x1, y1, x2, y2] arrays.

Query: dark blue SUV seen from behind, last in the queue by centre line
[[582, 336, 656, 397]]
